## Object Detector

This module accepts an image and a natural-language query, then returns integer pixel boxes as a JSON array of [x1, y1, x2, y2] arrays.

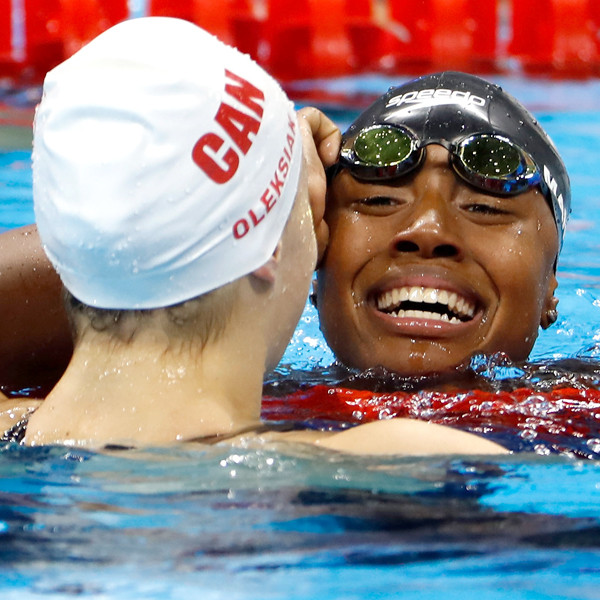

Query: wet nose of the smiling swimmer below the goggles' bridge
[[392, 145, 463, 259]]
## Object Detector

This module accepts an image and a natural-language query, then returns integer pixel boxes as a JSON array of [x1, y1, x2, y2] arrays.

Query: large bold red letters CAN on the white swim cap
[[192, 69, 265, 183]]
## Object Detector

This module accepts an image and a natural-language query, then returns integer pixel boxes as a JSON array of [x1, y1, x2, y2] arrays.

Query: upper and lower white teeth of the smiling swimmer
[[377, 286, 475, 323]]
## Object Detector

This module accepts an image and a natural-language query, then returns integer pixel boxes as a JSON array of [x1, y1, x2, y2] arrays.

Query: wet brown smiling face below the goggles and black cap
[[317, 145, 558, 375]]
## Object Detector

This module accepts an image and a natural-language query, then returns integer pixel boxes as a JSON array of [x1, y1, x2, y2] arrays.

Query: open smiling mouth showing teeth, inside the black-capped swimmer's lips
[[375, 286, 475, 323]]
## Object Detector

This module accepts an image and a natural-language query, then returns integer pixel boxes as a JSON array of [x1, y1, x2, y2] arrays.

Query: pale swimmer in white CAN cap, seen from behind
[[4, 17, 503, 454]]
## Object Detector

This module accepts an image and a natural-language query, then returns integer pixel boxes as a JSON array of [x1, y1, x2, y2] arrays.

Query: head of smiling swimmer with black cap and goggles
[[317, 72, 570, 375]]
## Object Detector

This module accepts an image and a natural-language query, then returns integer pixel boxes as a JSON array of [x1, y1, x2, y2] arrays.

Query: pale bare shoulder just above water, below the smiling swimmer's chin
[[261, 418, 508, 456]]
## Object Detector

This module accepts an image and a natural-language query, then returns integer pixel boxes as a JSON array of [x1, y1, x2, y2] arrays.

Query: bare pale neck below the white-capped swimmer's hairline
[[25, 322, 266, 446]]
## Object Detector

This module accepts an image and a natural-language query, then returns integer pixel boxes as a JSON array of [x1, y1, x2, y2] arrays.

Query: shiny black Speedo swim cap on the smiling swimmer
[[342, 71, 571, 246]]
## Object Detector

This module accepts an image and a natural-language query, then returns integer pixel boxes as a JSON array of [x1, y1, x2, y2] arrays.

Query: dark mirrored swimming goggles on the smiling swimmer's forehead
[[337, 125, 543, 196]]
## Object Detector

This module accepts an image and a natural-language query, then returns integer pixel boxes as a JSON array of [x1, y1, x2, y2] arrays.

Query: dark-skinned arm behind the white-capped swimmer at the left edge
[[0, 226, 72, 388]]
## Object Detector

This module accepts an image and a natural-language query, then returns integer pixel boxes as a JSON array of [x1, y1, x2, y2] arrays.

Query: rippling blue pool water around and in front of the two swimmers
[[0, 78, 600, 600]]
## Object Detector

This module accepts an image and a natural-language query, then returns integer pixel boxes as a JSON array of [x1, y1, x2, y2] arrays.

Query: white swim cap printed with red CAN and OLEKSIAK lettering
[[33, 17, 302, 309]]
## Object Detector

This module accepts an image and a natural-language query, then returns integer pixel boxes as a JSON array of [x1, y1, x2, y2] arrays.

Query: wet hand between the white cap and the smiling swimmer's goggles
[[298, 107, 342, 266]]
